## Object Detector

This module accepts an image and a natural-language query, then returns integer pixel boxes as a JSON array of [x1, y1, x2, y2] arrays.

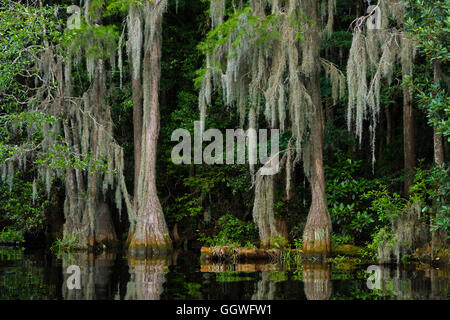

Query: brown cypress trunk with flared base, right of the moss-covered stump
[[303, 0, 331, 257]]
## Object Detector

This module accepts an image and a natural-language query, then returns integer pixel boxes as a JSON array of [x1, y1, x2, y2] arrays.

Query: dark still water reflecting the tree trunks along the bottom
[[0, 247, 450, 300]]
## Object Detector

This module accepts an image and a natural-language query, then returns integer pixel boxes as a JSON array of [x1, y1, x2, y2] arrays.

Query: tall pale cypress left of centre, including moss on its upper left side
[[127, 0, 172, 255]]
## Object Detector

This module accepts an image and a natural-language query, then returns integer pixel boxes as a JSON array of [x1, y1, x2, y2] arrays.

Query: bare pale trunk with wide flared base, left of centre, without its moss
[[128, 0, 172, 256]]
